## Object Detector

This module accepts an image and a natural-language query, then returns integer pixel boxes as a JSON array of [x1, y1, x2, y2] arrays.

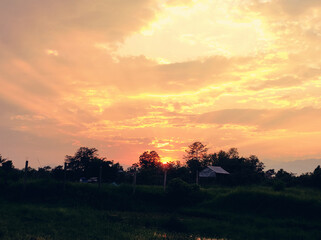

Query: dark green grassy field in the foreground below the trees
[[0, 181, 321, 240]]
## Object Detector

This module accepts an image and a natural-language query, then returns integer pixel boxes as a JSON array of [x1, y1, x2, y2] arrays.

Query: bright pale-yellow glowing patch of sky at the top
[[115, 0, 271, 64]]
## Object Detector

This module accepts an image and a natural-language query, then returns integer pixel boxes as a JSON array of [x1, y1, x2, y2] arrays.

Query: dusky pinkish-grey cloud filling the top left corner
[[0, 0, 156, 44]]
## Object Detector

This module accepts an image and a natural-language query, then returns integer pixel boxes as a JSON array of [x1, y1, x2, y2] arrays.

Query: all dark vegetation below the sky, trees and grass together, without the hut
[[0, 142, 321, 240]]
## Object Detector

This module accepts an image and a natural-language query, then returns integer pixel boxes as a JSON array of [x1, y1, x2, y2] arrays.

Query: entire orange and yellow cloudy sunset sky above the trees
[[0, 0, 321, 172]]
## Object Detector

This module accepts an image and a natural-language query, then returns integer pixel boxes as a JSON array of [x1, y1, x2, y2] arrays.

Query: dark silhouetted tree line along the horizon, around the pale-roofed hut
[[0, 142, 321, 190]]
